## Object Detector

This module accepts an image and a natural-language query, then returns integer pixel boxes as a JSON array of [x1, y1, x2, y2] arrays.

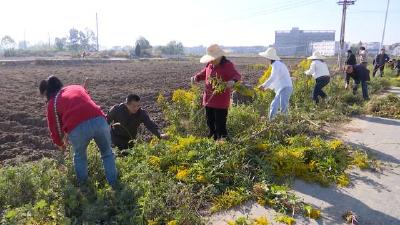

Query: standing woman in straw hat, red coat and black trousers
[[191, 44, 241, 140]]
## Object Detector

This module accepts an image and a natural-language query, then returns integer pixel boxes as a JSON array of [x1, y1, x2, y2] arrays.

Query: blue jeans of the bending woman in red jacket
[[68, 117, 117, 185]]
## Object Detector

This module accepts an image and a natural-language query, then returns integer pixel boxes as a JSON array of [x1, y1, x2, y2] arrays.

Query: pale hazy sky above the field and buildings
[[0, 0, 400, 47]]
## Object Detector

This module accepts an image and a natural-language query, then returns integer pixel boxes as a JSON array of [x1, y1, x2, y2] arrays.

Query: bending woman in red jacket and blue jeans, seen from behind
[[39, 76, 117, 186]]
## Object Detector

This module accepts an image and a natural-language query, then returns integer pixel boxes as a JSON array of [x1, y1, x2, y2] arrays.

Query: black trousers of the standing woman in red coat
[[206, 107, 228, 140]]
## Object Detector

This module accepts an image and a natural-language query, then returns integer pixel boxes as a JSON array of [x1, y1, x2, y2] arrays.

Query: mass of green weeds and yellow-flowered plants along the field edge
[[0, 59, 392, 225]]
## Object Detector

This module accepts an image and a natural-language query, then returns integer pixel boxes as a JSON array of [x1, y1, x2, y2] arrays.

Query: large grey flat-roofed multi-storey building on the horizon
[[274, 27, 335, 56]]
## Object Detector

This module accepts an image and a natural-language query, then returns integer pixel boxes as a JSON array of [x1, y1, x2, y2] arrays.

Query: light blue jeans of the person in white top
[[269, 87, 293, 120]]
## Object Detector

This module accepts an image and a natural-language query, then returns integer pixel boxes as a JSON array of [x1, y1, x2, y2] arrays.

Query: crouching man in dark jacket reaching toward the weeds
[[107, 94, 166, 150]]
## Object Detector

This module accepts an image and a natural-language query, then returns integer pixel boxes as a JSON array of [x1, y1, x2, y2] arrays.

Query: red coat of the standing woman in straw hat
[[195, 61, 241, 109]]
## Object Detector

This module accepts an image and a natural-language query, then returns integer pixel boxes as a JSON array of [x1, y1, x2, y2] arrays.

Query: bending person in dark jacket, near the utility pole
[[345, 64, 370, 100]]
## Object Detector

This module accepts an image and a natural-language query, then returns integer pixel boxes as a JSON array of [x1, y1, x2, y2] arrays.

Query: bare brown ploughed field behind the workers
[[0, 58, 282, 165]]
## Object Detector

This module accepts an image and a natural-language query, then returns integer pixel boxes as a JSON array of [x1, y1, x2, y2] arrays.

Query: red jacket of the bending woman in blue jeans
[[47, 85, 105, 146]]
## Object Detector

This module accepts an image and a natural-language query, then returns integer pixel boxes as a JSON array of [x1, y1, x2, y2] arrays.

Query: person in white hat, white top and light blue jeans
[[259, 48, 293, 120]]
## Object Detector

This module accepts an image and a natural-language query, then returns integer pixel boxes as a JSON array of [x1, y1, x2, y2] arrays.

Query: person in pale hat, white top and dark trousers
[[305, 52, 331, 104]]
